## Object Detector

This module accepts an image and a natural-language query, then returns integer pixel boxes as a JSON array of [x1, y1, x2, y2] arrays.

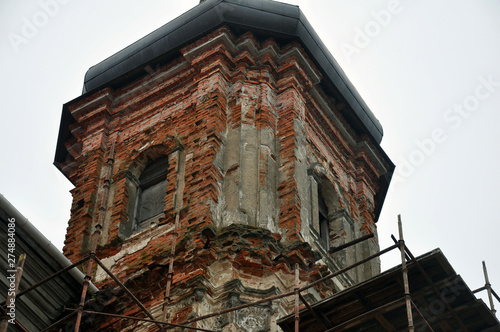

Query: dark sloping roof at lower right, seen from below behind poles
[[278, 249, 500, 332]]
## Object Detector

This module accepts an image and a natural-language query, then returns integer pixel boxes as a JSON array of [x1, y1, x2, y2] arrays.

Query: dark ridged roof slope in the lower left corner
[[0, 194, 97, 331]]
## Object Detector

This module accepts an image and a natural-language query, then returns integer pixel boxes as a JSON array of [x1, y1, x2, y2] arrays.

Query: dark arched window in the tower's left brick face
[[134, 157, 168, 230]]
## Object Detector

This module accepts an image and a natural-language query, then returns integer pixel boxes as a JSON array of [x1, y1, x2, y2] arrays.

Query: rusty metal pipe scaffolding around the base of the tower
[[0, 215, 500, 332]]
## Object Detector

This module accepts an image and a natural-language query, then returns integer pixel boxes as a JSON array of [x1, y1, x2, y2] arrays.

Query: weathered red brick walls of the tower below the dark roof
[[59, 28, 390, 328]]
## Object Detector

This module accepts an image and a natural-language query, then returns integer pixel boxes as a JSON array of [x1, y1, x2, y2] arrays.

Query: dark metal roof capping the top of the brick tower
[[83, 0, 383, 143]]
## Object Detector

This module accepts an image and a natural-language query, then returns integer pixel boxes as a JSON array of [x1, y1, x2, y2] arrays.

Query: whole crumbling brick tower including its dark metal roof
[[55, 0, 394, 331]]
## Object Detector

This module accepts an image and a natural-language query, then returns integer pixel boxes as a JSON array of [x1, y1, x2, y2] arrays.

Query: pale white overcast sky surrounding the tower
[[0, 0, 500, 307]]
